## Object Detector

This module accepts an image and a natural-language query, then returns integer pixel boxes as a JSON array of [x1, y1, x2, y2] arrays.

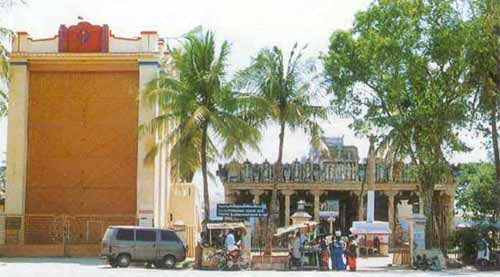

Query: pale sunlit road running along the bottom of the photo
[[0, 258, 500, 277]]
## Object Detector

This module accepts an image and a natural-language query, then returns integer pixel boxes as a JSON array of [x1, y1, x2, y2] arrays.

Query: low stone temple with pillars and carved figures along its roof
[[218, 137, 456, 247]]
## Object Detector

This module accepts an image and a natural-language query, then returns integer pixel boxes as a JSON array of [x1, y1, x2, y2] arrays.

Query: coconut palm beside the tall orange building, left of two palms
[[141, 32, 260, 222]]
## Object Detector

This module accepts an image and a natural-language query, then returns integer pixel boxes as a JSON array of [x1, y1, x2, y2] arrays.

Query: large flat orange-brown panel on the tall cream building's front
[[26, 71, 139, 215]]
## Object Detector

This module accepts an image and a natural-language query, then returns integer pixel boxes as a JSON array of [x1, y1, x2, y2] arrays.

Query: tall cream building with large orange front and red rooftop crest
[[0, 22, 199, 255]]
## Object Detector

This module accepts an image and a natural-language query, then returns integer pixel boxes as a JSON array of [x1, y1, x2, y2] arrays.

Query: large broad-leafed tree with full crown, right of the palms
[[323, 0, 468, 248]]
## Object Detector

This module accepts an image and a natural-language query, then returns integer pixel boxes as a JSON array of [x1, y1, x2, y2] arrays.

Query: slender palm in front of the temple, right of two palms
[[236, 44, 328, 253]]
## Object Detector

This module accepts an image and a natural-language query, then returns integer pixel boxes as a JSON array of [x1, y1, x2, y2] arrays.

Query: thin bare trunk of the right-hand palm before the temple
[[264, 122, 285, 255]]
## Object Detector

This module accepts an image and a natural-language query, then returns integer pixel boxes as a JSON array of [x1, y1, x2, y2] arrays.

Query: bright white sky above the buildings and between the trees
[[0, 0, 488, 211]]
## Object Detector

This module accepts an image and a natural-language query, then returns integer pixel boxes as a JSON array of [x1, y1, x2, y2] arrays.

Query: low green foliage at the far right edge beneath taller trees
[[457, 163, 498, 222]]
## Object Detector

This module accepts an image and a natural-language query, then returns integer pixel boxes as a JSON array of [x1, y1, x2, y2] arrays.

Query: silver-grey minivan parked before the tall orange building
[[101, 226, 186, 269]]
